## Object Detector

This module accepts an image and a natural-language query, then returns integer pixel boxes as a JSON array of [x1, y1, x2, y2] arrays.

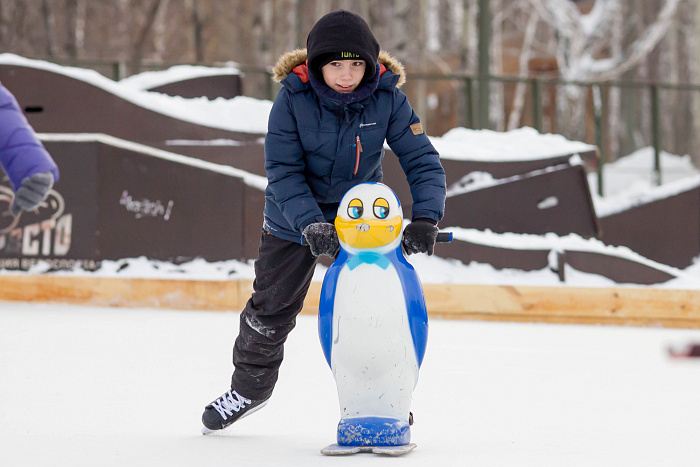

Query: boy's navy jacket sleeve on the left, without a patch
[[265, 88, 325, 238]]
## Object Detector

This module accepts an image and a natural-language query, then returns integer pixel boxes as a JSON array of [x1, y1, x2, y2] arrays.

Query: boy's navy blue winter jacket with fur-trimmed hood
[[264, 50, 445, 242]]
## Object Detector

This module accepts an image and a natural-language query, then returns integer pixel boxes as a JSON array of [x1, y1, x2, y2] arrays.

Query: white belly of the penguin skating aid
[[331, 263, 418, 420]]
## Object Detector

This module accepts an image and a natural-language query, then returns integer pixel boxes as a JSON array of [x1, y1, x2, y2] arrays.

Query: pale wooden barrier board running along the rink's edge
[[0, 275, 700, 329]]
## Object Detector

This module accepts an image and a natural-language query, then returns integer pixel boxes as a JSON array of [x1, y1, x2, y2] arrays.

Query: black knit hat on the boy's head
[[306, 10, 379, 81]]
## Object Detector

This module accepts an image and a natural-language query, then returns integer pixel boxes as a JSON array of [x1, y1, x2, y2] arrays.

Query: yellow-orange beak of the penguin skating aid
[[335, 216, 403, 249]]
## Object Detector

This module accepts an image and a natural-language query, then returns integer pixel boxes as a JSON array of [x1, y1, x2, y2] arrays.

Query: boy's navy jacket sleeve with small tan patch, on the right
[[386, 89, 446, 222]]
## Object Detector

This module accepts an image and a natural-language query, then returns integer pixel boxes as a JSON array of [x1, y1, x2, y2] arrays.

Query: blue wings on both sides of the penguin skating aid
[[318, 245, 428, 367]]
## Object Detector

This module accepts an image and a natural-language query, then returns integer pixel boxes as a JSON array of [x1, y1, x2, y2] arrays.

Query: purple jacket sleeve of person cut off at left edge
[[0, 84, 58, 191]]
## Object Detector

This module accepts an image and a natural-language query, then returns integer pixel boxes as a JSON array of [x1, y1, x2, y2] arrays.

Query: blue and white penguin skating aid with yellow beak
[[319, 183, 448, 455]]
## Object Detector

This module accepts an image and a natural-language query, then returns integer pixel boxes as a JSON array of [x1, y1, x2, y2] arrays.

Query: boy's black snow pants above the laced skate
[[231, 231, 317, 400]]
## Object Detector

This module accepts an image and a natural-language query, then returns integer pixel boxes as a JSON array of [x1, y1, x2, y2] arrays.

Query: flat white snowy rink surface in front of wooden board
[[0, 303, 700, 467]]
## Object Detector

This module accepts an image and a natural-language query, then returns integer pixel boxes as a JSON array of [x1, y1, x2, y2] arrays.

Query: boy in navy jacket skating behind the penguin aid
[[202, 10, 445, 433]]
